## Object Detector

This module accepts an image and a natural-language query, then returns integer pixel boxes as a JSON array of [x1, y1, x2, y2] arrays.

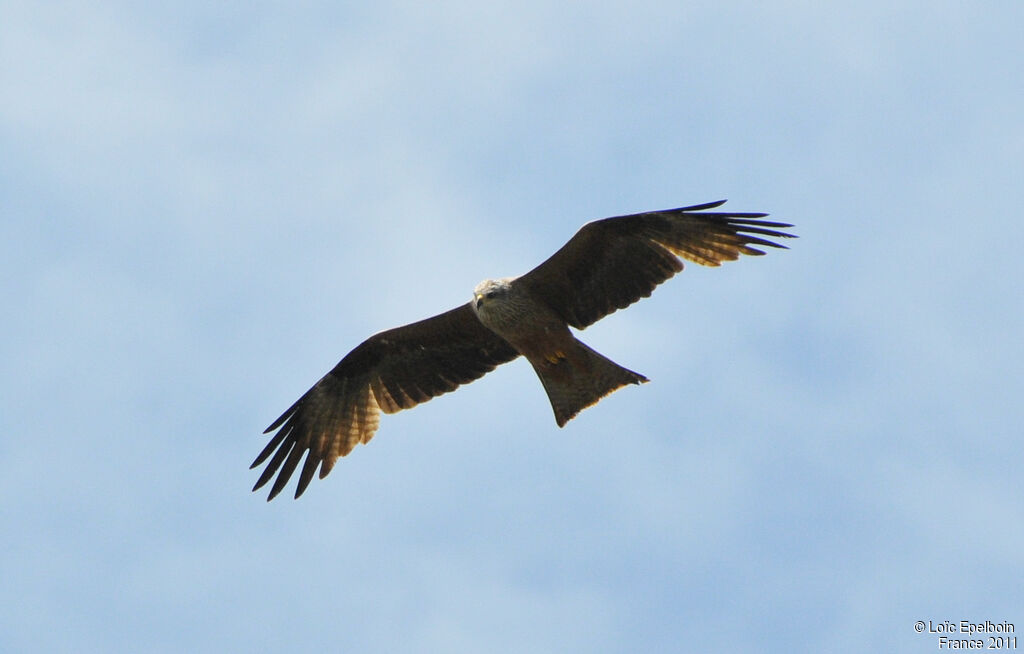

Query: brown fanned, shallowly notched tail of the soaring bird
[[530, 339, 648, 427]]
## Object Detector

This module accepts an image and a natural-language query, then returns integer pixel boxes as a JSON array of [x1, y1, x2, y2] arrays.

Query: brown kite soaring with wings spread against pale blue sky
[[251, 201, 794, 502]]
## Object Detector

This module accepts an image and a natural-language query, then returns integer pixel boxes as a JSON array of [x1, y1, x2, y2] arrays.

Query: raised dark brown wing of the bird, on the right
[[513, 200, 794, 330]]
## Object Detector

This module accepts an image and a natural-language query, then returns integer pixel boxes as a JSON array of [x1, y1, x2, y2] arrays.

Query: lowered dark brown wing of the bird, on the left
[[250, 304, 519, 502]]
